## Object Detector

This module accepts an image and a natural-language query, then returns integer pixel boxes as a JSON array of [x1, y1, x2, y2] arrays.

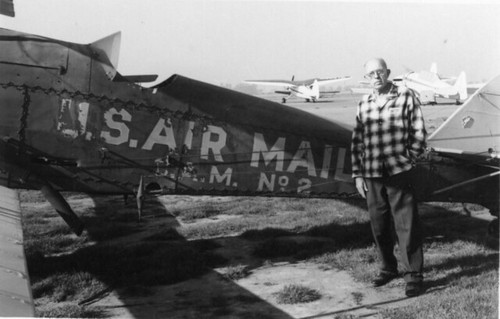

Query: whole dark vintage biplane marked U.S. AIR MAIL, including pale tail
[[0, 8, 500, 316]]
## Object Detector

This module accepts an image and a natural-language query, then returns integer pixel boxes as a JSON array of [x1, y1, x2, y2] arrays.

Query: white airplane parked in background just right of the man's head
[[393, 63, 468, 104]]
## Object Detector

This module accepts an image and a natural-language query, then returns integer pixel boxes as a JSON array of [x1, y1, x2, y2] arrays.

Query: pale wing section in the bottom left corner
[[0, 186, 35, 317]]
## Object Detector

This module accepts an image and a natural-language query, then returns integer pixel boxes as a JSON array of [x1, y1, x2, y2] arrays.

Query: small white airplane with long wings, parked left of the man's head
[[245, 76, 351, 103]]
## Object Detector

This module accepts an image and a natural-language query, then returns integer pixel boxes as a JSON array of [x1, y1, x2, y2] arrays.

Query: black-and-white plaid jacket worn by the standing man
[[351, 83, 427, 178]]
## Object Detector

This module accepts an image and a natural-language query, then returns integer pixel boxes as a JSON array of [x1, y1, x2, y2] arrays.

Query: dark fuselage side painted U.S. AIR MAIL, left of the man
[[0, 30, 354, 195]]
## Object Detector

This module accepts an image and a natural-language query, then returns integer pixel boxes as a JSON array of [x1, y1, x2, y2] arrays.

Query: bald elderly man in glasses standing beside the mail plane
[[351, 58, 426, 297]]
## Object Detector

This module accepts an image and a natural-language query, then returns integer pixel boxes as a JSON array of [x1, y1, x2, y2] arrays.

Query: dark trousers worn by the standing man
[[365, 171, 424, 282]]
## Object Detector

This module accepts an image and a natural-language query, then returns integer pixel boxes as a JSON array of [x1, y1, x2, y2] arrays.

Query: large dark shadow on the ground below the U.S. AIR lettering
[[26, 197, 296, 319]]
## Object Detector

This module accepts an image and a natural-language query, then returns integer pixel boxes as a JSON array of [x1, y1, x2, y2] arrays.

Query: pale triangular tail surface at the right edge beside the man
[[428, 75, 500, 159]]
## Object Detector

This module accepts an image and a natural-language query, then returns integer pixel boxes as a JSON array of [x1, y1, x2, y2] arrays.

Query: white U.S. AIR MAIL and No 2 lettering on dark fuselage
[[58, 99, 351, 193]]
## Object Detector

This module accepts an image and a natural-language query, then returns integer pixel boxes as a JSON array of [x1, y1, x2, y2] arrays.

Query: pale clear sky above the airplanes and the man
[[0, 0, 500, 85]]
